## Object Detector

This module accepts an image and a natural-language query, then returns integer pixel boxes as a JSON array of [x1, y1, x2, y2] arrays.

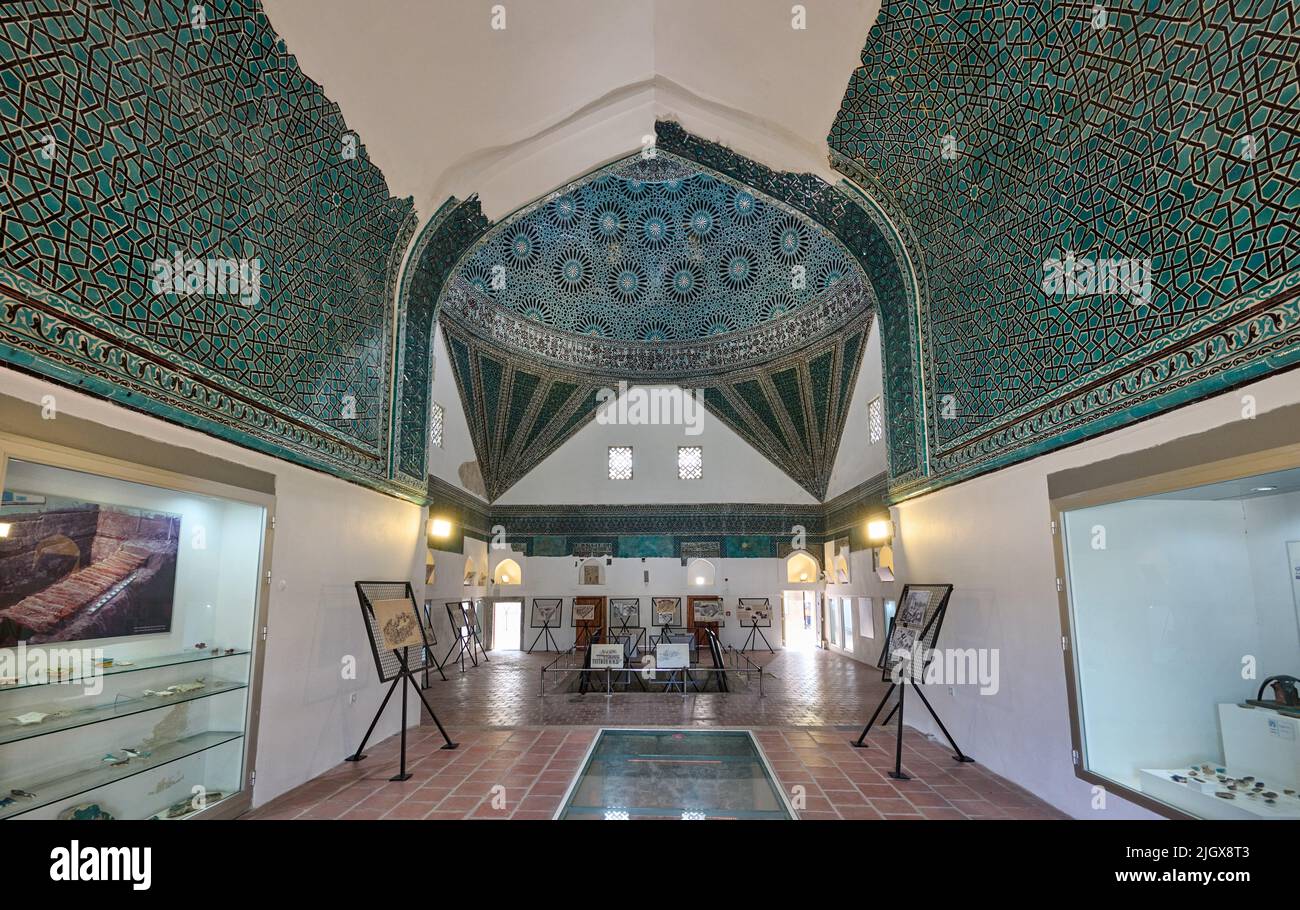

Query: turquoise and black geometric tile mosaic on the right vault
[[829, 0, 1300, 494]]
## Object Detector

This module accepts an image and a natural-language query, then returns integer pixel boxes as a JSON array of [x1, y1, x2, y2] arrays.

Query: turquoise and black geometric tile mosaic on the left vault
[[0, 0, 425, 497]]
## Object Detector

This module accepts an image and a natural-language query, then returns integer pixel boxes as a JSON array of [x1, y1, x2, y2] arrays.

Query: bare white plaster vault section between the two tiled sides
[[264, 0, 880, 221]]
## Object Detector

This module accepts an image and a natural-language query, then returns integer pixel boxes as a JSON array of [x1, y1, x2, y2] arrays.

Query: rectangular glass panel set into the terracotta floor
[[556, 729, 794, 820]]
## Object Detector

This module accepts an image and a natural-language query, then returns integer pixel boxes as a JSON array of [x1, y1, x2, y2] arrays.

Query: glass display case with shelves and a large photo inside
[[0, 434, 273, 819]]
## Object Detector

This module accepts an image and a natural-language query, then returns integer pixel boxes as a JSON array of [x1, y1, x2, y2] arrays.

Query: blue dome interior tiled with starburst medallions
[[458, 153, 857, 342]]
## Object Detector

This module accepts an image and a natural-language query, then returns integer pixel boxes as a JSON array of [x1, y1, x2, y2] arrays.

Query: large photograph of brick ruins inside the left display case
[[0, 502, 181, 647]]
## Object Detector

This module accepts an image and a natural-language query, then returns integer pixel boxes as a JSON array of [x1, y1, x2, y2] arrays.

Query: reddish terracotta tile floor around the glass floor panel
[[244, 651, 1065, 819]]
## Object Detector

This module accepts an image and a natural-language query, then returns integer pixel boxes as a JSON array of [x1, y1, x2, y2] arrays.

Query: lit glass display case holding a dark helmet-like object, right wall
[[1060, 468, 1300, 819]]
